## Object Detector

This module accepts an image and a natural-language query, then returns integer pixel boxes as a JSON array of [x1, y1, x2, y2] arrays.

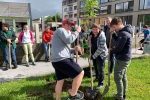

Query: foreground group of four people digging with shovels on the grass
[[51, 17, 133, 100]]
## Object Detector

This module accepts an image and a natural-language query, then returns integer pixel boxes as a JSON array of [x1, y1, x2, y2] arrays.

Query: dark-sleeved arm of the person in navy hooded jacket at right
[[112, 33, 127, 53]]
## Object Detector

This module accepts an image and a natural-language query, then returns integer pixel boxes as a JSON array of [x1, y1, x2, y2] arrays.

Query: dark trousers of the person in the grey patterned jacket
[[93, 57, 105, 85]]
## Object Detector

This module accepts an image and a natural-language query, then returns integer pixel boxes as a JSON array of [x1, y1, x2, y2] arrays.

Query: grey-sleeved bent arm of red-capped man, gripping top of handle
[[56, 29, 79, 44]]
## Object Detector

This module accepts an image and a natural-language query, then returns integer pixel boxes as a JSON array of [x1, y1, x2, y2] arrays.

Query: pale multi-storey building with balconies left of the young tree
[[62, 0, 79, 22]]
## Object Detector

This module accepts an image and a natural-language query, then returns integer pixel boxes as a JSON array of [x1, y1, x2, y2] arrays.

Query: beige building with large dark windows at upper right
[[79, 0, 150, 26]]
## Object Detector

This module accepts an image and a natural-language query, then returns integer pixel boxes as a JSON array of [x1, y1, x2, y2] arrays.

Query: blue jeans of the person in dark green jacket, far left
[[2, 46, 17, 65]]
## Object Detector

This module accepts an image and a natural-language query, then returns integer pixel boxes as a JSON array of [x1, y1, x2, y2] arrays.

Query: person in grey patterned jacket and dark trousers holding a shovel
[[90, 24, 108, 88]]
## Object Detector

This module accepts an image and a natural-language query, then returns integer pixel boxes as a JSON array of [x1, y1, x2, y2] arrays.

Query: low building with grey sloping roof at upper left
[[0, 2, 32, 32]]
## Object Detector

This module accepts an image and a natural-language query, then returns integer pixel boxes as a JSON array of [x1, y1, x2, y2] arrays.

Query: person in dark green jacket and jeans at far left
[[0, 23, 17, 70]]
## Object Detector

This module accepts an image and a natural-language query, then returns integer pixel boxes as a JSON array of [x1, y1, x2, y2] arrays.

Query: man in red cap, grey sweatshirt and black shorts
[[51, 19, 84, 100]]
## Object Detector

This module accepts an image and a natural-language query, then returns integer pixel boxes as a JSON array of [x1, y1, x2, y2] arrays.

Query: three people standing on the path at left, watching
[[0, 23, 53, 71]]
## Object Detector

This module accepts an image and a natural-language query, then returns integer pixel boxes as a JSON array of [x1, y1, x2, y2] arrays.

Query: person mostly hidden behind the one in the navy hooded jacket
[[104, 17, 115, 73]]
